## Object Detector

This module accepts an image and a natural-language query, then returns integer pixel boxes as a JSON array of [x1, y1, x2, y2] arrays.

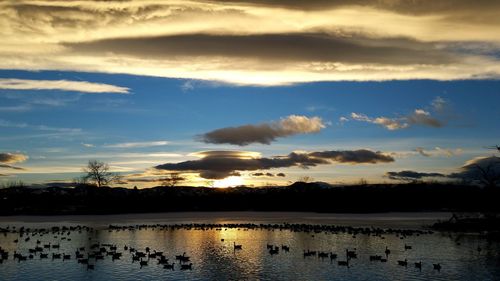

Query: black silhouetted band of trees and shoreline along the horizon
[[0, 182, 500, 215]]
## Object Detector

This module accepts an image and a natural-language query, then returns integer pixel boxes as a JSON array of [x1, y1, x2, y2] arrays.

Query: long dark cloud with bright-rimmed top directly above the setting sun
[[155, 149, 394, 179]]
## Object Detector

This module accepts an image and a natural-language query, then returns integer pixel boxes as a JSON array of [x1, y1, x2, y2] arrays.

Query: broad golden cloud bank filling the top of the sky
[[0, 0, 500, 84]]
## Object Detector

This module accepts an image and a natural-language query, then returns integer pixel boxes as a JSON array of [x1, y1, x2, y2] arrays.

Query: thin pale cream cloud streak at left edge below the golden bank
[[0, 78, 129, 94]]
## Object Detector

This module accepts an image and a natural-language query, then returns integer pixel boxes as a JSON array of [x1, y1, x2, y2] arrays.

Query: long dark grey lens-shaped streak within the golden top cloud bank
[[64, 33, 455, 65]]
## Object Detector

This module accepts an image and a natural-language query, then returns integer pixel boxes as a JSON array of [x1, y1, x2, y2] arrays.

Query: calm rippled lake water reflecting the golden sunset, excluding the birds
[[0, 213, 500, 281]]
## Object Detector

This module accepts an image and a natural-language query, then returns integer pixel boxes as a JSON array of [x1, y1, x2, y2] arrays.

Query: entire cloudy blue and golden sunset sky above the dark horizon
[[0, 0, 500, 187]]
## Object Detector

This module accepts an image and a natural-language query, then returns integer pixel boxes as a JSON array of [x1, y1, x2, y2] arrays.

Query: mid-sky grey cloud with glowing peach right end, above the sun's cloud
[[198, 115, 325, 146]]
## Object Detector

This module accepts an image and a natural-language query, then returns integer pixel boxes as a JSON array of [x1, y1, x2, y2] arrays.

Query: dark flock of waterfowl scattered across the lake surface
[[0, 224, 454, 271]]
